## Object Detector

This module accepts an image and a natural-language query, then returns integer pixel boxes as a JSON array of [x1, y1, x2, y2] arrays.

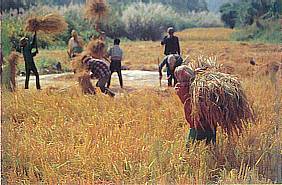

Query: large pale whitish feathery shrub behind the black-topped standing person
[[122, 3, 178, 40]]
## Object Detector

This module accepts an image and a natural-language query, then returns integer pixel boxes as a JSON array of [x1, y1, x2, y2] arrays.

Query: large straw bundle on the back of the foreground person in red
[[181, 56, 254, 135]]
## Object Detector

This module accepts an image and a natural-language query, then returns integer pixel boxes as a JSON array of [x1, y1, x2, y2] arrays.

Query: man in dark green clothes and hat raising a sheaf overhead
[[20, 32, 41, 89]]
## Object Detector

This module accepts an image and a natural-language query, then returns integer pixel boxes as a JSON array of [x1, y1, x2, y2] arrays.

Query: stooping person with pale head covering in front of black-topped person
[[159, 54, 183, 87]]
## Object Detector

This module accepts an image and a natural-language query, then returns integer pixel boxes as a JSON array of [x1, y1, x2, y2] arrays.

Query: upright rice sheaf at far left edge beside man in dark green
[[2, 51, 20, 92]]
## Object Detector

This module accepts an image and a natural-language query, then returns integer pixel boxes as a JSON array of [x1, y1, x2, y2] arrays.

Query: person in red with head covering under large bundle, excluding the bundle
[[174, 65, 216, 148]]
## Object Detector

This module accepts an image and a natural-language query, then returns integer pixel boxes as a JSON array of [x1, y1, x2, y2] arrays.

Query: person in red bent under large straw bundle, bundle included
[[175, 57, 254, 147]]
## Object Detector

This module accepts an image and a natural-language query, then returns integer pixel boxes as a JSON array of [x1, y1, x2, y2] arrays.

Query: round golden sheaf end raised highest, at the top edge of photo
[[85, 0, 109, 21]]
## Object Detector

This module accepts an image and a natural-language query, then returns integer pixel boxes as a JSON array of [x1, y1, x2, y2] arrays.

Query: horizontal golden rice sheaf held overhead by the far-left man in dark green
[[25, 14, 68, 34]]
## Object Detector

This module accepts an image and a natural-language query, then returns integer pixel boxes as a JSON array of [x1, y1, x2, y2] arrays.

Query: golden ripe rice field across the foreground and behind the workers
[[1, 27, 282, 184]]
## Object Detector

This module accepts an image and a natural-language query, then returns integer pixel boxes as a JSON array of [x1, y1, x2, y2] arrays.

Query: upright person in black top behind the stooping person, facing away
[[161, 27, 180, 55]]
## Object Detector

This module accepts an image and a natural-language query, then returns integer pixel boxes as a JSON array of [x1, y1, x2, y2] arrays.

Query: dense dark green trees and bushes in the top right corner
[[220, 0, 282, 43]]
